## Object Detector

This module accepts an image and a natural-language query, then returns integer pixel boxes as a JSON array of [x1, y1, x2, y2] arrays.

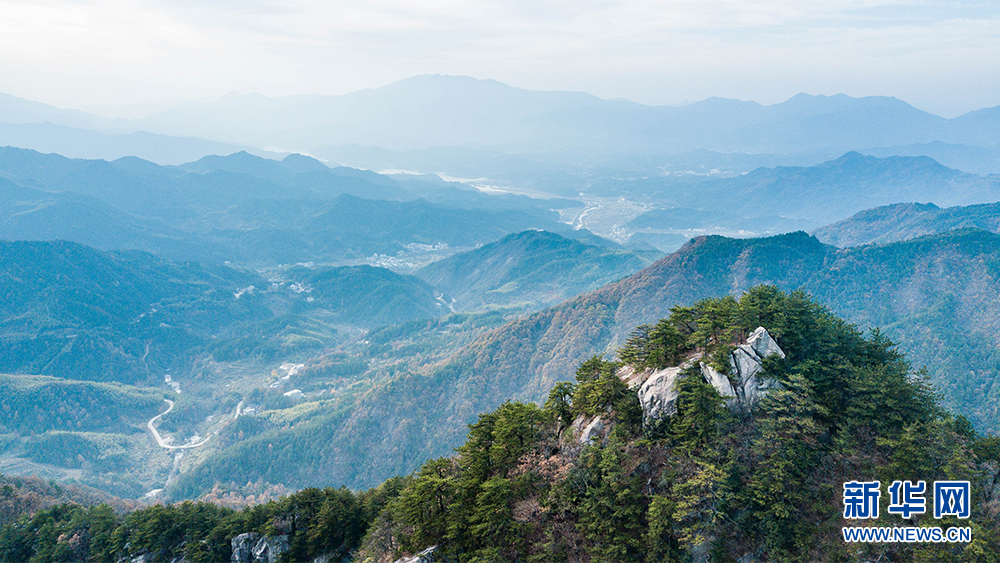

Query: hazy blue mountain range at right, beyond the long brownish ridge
[[626, 152, 1000, 236]]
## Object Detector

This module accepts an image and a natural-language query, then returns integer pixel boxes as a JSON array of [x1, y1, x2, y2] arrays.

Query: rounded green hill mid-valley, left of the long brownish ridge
[[416, 231, 650, 311]]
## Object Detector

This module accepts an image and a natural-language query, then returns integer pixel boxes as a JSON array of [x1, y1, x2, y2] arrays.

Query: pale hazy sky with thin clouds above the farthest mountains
[[0, 0, 1000, 116]]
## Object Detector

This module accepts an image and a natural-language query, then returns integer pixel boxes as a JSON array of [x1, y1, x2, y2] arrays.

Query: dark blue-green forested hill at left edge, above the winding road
[[0, 241, 268, 383]]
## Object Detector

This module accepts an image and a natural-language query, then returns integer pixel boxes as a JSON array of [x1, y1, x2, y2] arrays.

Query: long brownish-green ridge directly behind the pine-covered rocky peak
[[166, 230, 1000, 496]]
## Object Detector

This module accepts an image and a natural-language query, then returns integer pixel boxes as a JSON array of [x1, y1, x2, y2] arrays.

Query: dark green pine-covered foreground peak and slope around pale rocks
[[0, 286, 1000, 563]]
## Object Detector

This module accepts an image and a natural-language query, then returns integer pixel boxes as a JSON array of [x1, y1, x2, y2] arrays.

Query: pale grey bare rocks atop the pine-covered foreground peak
[[636, 327, 785, 424]]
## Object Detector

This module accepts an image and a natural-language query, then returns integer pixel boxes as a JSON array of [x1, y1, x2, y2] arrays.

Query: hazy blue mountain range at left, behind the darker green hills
[[0, 148, 592, 266]]
